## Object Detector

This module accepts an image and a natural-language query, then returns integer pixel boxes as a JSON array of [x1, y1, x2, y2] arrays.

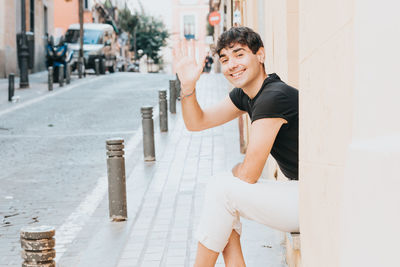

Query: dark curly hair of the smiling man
[[214, 27, 264, 56]]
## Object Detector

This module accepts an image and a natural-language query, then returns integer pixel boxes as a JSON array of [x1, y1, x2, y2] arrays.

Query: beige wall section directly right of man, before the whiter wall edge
[[299, 0, 354, 267]]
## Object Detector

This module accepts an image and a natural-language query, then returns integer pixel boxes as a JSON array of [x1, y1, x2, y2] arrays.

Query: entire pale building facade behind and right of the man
[[221, 0, 400, 267]]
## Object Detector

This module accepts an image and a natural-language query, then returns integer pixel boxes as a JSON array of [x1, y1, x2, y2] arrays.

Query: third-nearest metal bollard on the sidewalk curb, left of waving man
[[140, 107, 156, 161]]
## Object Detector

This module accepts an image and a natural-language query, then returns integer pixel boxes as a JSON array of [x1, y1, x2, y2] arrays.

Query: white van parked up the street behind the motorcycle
[[65, 23, 119, 74]]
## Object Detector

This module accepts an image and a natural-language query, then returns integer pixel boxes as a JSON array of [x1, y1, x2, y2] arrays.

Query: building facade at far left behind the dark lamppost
[[0, 0, 54, 78]]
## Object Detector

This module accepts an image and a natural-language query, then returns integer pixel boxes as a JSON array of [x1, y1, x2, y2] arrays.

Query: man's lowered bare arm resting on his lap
[[232, 118, 287, 184]]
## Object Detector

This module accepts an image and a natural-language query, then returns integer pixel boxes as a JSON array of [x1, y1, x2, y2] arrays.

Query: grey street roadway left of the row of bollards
[[0, 73, 173, 266]]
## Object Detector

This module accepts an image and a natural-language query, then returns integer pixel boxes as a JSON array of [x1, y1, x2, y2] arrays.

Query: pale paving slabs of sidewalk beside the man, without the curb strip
[[111, 74, 286, 267]]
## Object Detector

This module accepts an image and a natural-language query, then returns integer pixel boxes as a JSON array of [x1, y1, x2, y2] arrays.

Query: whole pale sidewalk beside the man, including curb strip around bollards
[[65, 74, 286, 267]]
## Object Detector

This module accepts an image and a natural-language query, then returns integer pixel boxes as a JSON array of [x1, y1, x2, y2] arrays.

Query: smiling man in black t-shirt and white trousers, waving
[[175, 27, 299, 266]]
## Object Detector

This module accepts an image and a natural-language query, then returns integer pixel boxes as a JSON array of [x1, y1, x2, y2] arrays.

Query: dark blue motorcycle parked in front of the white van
[[46, 36, 73, 82]]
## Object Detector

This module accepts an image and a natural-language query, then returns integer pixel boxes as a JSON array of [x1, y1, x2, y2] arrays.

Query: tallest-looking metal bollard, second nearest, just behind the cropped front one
[[106, 138, 128, 222]]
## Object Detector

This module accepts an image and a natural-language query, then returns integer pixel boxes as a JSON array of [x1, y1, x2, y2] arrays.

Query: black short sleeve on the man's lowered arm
[[252, 90, 294, 123]]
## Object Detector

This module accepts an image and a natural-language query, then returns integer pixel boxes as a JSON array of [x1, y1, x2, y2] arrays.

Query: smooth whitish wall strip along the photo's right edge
[[339, 0, 400, 267]]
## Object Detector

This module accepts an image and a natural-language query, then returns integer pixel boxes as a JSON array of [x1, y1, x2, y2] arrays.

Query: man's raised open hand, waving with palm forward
[[174, 40, 204, 93]]
